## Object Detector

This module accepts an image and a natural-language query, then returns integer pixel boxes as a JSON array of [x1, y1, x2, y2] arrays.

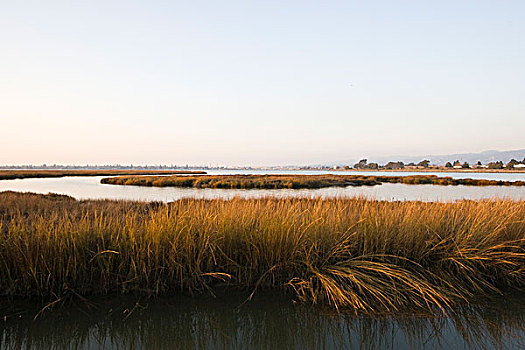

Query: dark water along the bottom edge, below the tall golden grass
[[0, 295, 525, 349]]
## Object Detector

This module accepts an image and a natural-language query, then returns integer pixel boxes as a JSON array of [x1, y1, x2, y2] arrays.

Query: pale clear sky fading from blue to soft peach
[[0, 0, 525, 166]]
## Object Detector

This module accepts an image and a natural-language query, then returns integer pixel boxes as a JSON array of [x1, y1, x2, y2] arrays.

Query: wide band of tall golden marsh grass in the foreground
[[0, 192, 525, 312]]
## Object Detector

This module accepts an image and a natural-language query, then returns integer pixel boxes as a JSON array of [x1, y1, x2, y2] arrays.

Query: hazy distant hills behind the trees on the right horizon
[[338, 149, 525, 165]]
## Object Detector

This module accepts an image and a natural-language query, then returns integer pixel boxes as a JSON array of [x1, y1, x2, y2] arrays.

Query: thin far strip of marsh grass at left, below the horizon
[[0, 170, 206, 180]]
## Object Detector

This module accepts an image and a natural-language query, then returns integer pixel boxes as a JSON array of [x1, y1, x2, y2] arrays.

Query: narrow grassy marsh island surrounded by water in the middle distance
[[101, 175, 525, 189]]
